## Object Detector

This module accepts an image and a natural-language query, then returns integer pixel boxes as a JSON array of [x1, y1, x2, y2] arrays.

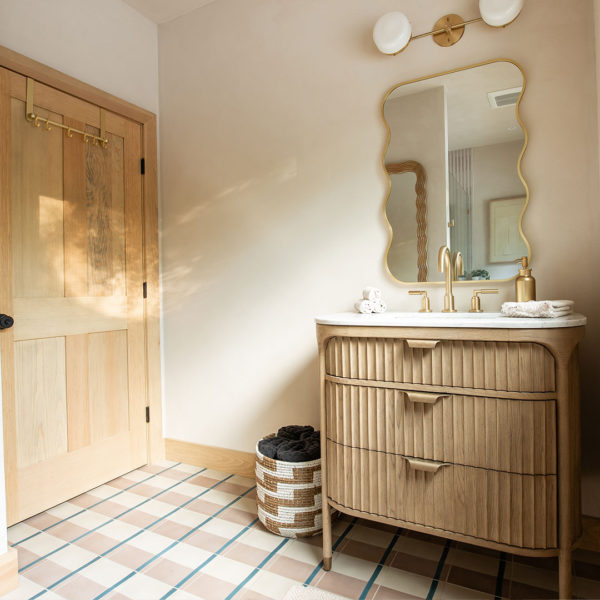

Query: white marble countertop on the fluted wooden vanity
[[315, 312, 587, 329]]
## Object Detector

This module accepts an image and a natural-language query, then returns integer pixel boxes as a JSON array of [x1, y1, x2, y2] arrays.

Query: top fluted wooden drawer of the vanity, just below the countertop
[[325, 337, 555, 392]]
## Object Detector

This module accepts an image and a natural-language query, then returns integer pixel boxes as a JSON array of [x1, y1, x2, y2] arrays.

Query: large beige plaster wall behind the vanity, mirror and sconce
[[159, 0, 600, 513]]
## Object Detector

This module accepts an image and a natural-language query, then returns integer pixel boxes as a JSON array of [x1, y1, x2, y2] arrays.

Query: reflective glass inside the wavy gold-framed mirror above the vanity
[[383, 60, 529, 282]]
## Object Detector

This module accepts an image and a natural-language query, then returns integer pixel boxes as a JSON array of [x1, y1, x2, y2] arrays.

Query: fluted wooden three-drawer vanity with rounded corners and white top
[[317, 314, 585, 598]]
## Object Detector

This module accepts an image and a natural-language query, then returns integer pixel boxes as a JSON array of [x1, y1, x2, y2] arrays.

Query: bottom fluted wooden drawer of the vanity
[[327, 441, 557, 549]]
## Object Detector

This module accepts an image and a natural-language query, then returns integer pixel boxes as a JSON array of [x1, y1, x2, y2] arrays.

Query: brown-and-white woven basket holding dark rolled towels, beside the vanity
[[256, 436, 323, 538]]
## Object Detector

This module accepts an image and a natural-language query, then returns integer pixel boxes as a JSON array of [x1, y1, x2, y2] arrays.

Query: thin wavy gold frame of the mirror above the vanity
[[381, 58, 532, 286]]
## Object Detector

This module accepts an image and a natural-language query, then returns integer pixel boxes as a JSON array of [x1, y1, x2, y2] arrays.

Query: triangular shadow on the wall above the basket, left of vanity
[[240, 356, 320, 441]]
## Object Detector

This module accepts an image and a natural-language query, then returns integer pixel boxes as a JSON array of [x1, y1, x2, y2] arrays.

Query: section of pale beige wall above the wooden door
[[0, 0, 158, 113]]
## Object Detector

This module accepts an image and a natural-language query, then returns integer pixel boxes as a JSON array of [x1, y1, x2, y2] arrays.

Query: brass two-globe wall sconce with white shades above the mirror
[[373, 0, 523, 54]]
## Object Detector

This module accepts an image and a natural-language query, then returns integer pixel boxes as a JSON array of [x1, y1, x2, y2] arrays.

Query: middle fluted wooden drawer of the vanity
[[325, 381, 556, 475]]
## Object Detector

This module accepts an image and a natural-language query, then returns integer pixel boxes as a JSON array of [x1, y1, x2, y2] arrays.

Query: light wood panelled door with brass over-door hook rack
[[0, 69, 147, 524]]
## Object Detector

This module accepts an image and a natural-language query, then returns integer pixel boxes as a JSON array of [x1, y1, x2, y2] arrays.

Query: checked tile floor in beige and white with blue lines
[[6, 462, 600, 600]]
